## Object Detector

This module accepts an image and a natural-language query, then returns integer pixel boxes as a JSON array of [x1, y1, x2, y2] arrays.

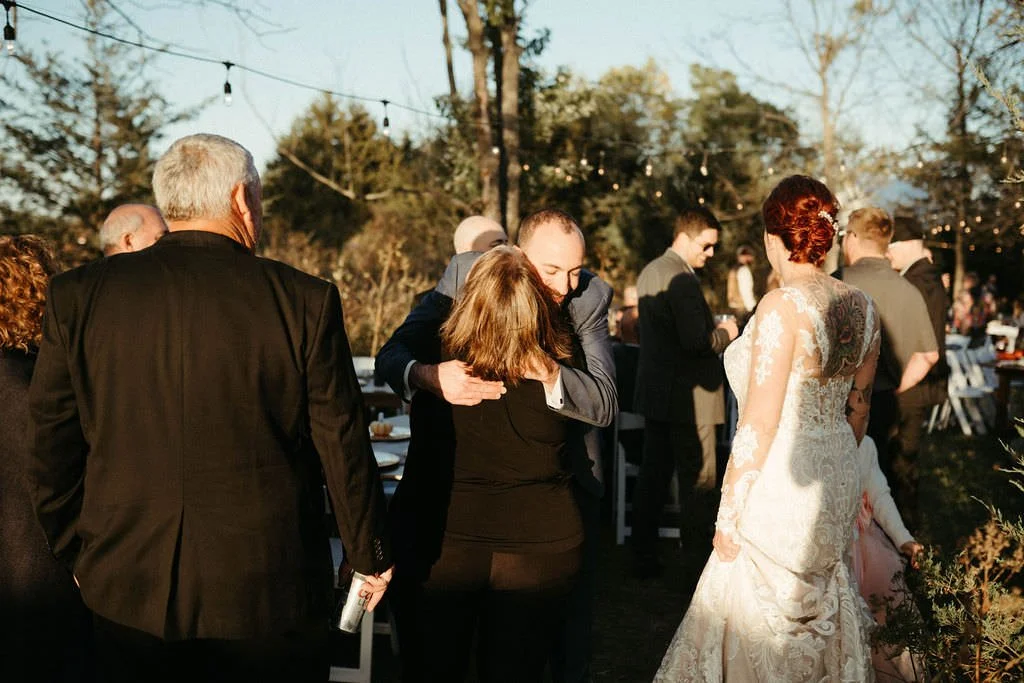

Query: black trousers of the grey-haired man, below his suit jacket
[[93, 616, 330, 683]]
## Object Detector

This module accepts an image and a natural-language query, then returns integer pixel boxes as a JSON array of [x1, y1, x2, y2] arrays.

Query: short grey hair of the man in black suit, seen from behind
[[153, 133, 260, 220]]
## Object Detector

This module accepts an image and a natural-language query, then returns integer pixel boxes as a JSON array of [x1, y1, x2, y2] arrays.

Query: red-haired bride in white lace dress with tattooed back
[[654, 176, 880, 683]]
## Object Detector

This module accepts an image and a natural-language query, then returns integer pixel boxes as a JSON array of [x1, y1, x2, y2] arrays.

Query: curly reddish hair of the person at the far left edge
[[0, 234, 57, 351]]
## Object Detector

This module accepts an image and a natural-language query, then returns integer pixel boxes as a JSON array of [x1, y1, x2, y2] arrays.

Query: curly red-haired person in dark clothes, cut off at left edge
[[0, 236, 91, 683]]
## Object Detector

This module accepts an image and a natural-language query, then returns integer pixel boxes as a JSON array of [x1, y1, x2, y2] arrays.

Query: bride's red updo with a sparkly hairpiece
[[761, 175, 839, 265]]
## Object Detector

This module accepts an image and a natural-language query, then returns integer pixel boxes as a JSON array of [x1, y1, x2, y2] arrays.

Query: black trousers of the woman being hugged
[[392, 539, 580, 683]]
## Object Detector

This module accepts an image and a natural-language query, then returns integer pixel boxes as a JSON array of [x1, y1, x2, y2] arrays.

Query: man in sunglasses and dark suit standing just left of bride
[[631, 207, 737, 578]]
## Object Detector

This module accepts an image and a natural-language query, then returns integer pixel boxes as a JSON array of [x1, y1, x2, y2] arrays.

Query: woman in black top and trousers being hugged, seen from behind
[[396, 247, 583, 683]]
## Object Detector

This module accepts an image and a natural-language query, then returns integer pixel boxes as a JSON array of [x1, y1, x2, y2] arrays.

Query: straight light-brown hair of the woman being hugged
[[441, 247, 572, 385]]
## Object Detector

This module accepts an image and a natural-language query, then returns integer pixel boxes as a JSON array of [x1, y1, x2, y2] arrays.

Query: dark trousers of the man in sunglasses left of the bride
[[630, 420, 717, 560]]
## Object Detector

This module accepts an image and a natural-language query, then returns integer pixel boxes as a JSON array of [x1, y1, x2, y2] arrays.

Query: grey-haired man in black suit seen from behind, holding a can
[[29, 135, 391, 681]]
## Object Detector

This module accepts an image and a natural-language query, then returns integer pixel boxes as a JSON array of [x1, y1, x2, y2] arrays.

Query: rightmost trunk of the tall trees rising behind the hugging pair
[[501, 12, 522, 241]]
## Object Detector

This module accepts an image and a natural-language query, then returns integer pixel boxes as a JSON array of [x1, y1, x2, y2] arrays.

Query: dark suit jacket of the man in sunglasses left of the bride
[[635, 249, 729, 425]]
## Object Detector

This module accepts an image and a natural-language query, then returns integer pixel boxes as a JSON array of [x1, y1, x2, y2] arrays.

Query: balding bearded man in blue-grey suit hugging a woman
[[377, 209, 617, 683]]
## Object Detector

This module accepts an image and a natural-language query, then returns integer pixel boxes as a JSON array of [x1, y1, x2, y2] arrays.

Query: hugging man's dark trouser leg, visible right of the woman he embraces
[[551, 485, 598, 683]]
